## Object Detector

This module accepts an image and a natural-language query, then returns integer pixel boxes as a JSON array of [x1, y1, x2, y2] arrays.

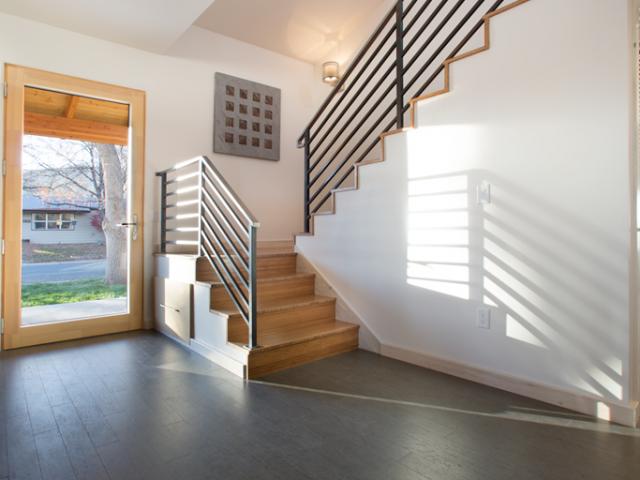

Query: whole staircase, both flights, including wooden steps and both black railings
[[156, 0, 528, 378]]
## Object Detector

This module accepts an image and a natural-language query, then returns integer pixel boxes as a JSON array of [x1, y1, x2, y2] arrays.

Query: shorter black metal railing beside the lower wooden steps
[[156, 156, 260, 349]]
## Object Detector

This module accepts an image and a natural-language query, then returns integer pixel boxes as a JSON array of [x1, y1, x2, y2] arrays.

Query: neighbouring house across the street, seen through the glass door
[[22, 194, 104, 243]]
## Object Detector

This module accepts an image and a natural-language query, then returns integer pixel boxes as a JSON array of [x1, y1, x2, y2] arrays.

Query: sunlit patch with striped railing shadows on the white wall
[[406, 170, 627, 400]]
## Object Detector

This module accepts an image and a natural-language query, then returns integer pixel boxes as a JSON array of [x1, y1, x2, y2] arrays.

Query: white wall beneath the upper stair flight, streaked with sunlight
[[298, 0, 635, 412]]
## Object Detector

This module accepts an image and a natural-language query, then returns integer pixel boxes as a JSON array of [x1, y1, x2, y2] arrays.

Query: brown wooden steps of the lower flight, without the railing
[[196, 243, 358, 378]]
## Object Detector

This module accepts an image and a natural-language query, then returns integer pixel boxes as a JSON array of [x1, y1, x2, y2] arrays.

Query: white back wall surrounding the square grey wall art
[[0, 14, 322, 330]]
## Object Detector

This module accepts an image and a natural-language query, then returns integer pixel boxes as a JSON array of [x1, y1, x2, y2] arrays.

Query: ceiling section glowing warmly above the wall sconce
[[196, 0, 384, 63]]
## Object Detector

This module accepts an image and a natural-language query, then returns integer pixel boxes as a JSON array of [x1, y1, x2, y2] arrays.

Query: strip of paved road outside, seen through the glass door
[[22, 260, 106, 284]]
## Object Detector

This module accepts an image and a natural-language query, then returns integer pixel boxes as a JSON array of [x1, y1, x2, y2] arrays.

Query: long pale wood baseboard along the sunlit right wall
[[380, 344, 640, 427]]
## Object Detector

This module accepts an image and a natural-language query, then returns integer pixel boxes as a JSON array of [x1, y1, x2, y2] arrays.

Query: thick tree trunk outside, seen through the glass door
[[96, 143, 129, 285]]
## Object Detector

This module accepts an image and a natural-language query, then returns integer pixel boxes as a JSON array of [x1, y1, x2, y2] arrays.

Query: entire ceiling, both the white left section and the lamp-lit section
[[0, 0, 388, 63]]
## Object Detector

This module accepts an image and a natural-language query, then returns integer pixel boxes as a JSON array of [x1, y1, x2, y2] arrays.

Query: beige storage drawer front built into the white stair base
[[155, 277, 193, 342]]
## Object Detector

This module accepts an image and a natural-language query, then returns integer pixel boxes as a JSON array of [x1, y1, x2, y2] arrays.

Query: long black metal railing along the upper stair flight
[[298, 0, 504, 232]]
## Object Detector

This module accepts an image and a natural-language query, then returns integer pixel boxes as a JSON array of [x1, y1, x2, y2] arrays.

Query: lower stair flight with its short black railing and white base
[[156, 157, 359, 378]]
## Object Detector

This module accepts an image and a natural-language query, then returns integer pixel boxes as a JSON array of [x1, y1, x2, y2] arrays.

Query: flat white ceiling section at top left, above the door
[[0, 0, 213, 53]]
